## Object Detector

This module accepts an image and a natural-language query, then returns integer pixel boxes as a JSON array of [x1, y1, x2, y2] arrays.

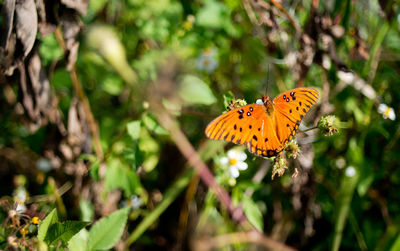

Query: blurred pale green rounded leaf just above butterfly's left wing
[[179, 75, 217, 105]]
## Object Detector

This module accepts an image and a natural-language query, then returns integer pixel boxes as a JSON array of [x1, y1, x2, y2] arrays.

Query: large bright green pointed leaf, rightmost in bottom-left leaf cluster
[[88, 207, 129, 250]]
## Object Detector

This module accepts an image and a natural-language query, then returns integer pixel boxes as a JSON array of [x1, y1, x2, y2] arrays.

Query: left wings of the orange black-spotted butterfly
[[206, 104, 281, 157]]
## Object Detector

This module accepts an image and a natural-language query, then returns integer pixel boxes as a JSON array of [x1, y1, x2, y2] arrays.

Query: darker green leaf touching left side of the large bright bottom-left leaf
[[44, 221, 89, 245]]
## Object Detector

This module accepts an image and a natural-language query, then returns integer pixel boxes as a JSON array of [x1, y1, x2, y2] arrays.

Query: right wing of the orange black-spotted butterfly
[[273, 88, 319, 146]]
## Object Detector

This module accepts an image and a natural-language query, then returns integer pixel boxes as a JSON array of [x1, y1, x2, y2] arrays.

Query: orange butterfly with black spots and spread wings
[[205, 88, 319, 157]]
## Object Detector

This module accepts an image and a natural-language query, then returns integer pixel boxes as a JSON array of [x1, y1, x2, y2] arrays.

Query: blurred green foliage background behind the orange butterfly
[[0, 0, 400, 250]]
